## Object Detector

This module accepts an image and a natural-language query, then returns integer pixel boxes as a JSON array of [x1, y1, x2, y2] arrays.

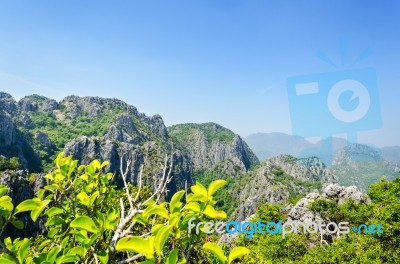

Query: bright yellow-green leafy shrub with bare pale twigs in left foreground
[[0, 153, 249, 264]]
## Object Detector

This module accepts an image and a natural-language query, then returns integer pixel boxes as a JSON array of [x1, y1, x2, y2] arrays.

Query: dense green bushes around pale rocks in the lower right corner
[[236, 175, 400, 264]]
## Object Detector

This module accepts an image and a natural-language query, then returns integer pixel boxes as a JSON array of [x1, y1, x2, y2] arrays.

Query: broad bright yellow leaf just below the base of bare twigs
[[115, 236, 154, 259]]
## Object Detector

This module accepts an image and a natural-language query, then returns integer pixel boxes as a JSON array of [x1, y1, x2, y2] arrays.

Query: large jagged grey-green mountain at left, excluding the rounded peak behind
[[0, 93, 178, 189]]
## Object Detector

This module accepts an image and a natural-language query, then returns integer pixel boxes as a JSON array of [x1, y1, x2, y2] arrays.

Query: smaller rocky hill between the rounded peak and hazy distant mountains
[[231, 155, 336, 221]]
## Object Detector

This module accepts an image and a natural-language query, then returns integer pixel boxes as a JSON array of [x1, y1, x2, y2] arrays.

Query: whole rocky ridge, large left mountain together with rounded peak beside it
[[0, 93, 258, 198]]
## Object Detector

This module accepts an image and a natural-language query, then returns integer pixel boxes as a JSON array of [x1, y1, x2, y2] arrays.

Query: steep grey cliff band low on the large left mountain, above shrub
[[64, 136, 192, 196]]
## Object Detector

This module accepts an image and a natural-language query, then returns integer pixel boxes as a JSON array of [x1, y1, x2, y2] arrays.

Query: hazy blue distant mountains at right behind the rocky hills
[[244, 133, 400, 191]]
